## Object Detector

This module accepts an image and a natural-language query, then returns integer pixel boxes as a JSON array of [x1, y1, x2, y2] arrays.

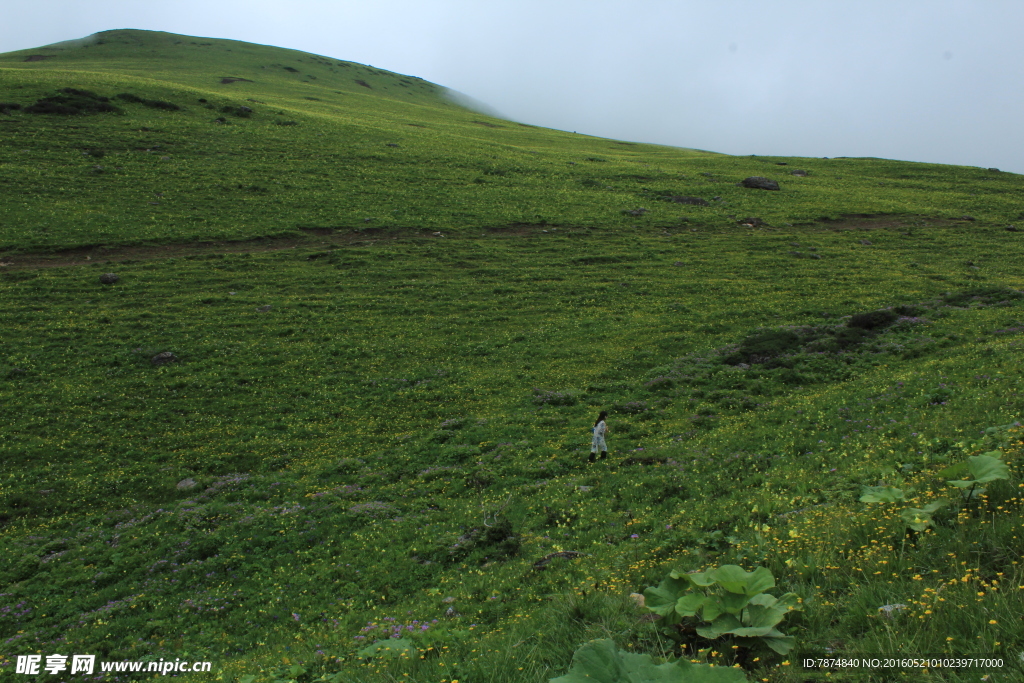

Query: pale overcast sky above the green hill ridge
[[0, 0, 1024, 173]]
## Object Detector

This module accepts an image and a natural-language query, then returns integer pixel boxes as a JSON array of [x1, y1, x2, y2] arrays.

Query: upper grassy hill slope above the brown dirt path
[[0, 31, 1021, 255]]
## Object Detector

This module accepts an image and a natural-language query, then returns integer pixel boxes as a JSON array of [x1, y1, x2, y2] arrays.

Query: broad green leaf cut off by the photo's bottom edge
[[549, 639, 746, 683]]
